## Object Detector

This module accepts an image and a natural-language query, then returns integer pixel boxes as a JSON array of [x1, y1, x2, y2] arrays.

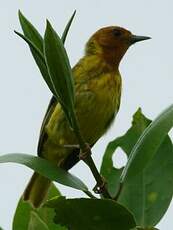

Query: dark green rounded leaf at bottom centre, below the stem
[[47, 197, 136, 230]]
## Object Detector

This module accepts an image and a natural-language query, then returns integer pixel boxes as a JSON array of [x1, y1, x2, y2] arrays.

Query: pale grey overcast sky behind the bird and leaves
[[0, 0, 173, 230]]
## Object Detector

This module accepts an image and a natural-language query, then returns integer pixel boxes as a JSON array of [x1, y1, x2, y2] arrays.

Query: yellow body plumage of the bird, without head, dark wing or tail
[[42, 57, 121, 164]]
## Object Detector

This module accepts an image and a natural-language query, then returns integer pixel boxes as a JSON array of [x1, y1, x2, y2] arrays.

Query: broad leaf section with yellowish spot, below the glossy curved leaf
[[118, 137, 173, 227]]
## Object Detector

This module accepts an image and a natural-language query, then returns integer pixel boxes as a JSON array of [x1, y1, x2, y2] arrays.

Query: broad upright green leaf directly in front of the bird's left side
[[44, 21, 74, 126]]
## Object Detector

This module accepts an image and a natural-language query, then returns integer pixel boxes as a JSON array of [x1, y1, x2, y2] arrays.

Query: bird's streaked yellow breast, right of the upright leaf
[[76, 73, 121, 143]]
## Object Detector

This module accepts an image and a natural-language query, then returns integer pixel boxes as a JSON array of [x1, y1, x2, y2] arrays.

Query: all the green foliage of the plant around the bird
[[0, 11, 173, 230]]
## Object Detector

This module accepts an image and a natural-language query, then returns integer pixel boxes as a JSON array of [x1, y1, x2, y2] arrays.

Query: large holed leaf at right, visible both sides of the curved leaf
[[101, 110, 173, 227]]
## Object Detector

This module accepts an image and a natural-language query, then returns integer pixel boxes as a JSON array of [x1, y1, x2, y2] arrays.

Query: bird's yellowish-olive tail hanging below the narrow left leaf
[[23, 173, 51, 208]]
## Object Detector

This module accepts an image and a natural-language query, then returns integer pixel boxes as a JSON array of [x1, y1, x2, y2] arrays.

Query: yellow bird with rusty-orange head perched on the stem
[[23, 26, 150, 208]]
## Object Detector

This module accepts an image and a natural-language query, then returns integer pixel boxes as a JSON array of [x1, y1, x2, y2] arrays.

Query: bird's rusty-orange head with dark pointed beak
[[86, 26, 150, 65]]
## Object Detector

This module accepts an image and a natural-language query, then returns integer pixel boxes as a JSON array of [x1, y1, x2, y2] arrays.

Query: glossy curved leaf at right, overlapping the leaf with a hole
[[120, 105, 173, 183]]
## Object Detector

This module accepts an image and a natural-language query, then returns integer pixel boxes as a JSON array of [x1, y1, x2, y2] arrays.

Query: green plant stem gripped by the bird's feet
[[72, 111, 112, 199]]
